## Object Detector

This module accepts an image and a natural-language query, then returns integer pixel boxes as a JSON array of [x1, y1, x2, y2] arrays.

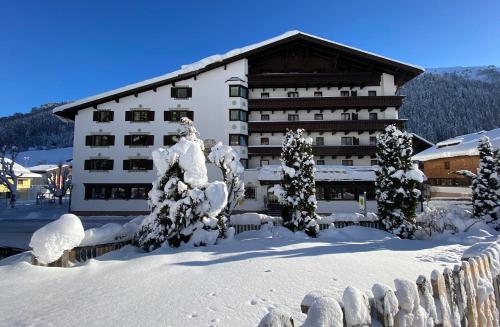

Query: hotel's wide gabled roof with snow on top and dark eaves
[[53, 31, 424, 119]]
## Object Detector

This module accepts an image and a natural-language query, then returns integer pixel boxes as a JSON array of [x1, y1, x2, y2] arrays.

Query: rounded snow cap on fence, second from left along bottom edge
[[302, 297, 343, 327]]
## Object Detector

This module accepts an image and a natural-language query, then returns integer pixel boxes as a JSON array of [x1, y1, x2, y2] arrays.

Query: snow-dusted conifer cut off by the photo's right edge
[[472, 136, 500, 225]]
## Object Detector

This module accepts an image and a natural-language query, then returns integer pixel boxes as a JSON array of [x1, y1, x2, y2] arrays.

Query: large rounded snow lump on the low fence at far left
[[30, 214, 85, 264]]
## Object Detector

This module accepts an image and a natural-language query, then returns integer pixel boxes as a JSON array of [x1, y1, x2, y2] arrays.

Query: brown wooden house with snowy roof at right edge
[[413, 128, 500, 196]]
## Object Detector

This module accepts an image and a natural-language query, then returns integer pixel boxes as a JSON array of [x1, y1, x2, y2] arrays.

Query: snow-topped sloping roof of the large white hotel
[[53, 30, 424, 117]]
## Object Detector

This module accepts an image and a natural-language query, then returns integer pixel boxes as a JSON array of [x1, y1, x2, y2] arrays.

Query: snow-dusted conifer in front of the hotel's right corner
[[375, 125, 423, 238]]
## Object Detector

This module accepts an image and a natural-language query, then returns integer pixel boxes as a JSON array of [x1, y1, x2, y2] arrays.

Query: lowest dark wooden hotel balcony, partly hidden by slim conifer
[[248, 145, 377, 156]]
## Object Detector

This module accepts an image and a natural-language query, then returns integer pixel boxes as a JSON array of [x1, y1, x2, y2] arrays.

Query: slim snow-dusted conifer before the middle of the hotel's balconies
[[275, 129, 319, 237]]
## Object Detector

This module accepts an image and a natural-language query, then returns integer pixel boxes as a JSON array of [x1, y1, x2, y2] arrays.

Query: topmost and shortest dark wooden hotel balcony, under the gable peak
[[248, 73, 380, 88]]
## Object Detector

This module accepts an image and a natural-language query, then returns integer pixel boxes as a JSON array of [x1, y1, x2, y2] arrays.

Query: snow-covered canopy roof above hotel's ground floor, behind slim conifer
[[257, 165, 375, 182]]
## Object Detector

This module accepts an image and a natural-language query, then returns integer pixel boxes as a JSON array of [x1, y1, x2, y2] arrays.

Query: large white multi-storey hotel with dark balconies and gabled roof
[[54, 31, 423, 214]]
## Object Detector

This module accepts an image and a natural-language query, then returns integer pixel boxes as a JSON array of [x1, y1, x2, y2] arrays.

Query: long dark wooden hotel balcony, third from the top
[[248, 119, 405, 133]]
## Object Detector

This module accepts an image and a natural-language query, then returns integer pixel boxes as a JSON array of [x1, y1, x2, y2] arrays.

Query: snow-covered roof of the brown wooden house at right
[[413, 128, 500, 161]]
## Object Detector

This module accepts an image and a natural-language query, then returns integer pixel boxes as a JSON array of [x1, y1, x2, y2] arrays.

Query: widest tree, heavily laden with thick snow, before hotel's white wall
[[136, 118, 227, 251]]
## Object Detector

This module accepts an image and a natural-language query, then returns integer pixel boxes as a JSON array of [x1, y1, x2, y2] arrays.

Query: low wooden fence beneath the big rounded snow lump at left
[[31, 241, 131, 267]]
